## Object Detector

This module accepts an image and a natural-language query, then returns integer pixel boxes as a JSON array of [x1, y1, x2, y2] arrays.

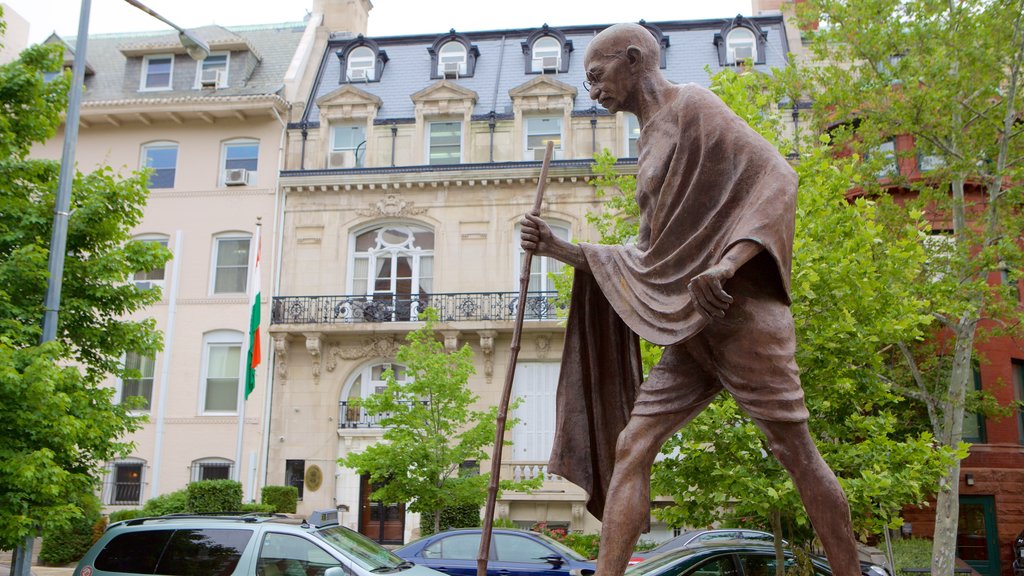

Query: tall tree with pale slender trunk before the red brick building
[[801, 0, 1024, 574]]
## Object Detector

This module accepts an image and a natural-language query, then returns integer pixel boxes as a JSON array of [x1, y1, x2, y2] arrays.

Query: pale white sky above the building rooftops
[[2, 0, 751, 43]]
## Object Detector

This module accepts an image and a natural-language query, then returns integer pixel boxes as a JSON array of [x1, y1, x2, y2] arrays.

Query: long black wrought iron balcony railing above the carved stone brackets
[[270, 291, 564, 324]]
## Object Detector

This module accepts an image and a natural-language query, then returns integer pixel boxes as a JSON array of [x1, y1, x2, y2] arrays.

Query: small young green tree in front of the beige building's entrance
[[338, 308, 537, 532]]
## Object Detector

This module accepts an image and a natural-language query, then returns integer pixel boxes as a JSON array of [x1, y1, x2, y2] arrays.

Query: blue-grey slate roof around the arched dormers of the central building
[[304, 15, 788, 124]]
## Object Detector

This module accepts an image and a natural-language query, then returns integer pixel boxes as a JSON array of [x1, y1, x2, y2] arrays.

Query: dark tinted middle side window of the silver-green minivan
[[155, 529, 253, 576]]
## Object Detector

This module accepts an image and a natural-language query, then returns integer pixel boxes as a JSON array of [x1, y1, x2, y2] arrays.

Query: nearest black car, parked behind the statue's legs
[[626, 540, 888, 576]]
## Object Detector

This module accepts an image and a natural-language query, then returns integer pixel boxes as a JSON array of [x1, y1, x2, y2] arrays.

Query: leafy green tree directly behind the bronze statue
[[573, 71, 952, 553]]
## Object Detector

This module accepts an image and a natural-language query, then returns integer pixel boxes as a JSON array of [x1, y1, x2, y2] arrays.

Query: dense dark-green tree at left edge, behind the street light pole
[[0, 39, 169, 548]]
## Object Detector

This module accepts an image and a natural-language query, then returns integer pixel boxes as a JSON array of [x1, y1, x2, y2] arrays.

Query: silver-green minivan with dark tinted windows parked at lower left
[[74, 515, 439, 576]]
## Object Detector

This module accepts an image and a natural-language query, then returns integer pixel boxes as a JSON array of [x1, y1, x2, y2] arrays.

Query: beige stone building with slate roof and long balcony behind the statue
[[267, 2, 788, 543]]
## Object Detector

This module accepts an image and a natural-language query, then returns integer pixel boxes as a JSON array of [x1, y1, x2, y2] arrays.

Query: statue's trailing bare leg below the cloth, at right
[[755, 418, 860, 576]]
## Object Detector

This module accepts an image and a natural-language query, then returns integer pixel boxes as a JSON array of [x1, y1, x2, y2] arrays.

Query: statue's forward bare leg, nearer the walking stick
[[597, 403, 707, 576]]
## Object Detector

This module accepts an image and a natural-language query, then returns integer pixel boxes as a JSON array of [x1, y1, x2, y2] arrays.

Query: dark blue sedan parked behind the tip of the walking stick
[[394, 528, 596, 576]]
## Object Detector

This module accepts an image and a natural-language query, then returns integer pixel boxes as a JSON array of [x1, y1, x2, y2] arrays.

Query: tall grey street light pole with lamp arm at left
[[16, 0, 210, 576]]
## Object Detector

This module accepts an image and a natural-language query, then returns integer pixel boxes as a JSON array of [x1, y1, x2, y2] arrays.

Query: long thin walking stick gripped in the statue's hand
[[476, 140, 554, 576]]
